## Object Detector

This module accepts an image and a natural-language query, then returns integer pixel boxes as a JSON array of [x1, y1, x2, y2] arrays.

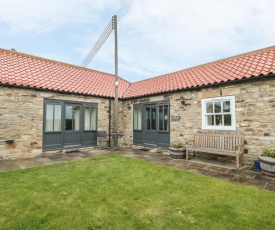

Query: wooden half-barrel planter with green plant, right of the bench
[[259, 149, 275, 177]]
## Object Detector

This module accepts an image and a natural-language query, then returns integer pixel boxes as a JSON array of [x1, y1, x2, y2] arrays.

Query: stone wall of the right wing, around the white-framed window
[[120, 77, 275, 155]]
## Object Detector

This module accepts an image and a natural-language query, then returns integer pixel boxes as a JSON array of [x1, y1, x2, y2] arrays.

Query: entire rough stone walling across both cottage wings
[[0, 78, 275, 159]]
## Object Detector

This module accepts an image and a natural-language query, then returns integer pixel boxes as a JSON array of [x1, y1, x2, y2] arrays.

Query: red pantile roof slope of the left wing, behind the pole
[[0, 49, 130, 97]]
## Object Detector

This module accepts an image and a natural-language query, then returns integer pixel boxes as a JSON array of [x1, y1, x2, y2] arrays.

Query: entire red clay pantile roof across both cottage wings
[[0, 46, 275, 98]]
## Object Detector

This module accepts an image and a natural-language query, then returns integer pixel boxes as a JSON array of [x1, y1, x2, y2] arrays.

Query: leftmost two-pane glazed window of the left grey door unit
[[45, 104, 61, 132]]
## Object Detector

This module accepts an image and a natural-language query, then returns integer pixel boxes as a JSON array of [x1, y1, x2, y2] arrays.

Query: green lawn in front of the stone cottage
[[0, 155, 275, 230]]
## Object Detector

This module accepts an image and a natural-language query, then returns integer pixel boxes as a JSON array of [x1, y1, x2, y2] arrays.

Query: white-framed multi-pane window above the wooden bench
[[202, 96, 236, 130]]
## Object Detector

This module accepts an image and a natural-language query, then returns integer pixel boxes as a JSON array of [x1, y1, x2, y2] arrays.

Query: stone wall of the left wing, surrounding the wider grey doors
[[0, 86, 112, 159]]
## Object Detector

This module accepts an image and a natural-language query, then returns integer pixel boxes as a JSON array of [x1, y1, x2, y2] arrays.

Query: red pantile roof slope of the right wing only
[[124, 46, 275, 98]]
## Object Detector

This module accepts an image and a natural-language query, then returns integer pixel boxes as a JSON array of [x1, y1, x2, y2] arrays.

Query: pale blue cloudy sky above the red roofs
[[0, 0, 275, 82]]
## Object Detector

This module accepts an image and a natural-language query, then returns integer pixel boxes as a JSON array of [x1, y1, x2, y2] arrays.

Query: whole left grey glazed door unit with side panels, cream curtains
[[43, 100, 97, 150]]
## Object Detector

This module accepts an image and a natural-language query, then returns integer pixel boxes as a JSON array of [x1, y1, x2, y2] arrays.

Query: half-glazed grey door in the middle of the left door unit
[[64, 103, 83, 147]]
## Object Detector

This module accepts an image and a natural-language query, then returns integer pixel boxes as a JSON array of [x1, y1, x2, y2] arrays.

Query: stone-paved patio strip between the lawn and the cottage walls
[[0, 147, 275, 192]]
